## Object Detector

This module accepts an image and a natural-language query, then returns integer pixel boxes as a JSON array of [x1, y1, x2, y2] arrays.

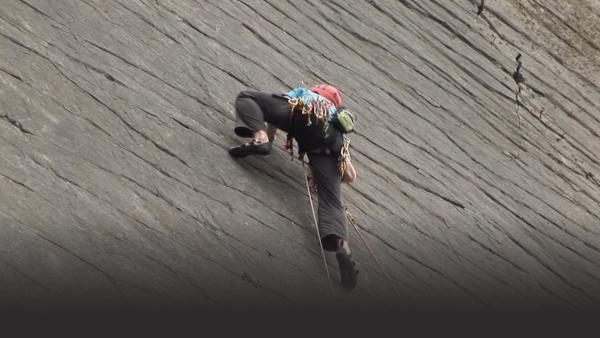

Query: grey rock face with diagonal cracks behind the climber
[[0, 0, 600, 309]]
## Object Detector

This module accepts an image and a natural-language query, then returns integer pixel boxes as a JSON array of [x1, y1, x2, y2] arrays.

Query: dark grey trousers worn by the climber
[[234, 91, 348, 251]]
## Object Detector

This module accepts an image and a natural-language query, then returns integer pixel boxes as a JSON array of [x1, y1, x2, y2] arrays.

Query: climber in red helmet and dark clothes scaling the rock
[[229, 84, 357, 289]]
